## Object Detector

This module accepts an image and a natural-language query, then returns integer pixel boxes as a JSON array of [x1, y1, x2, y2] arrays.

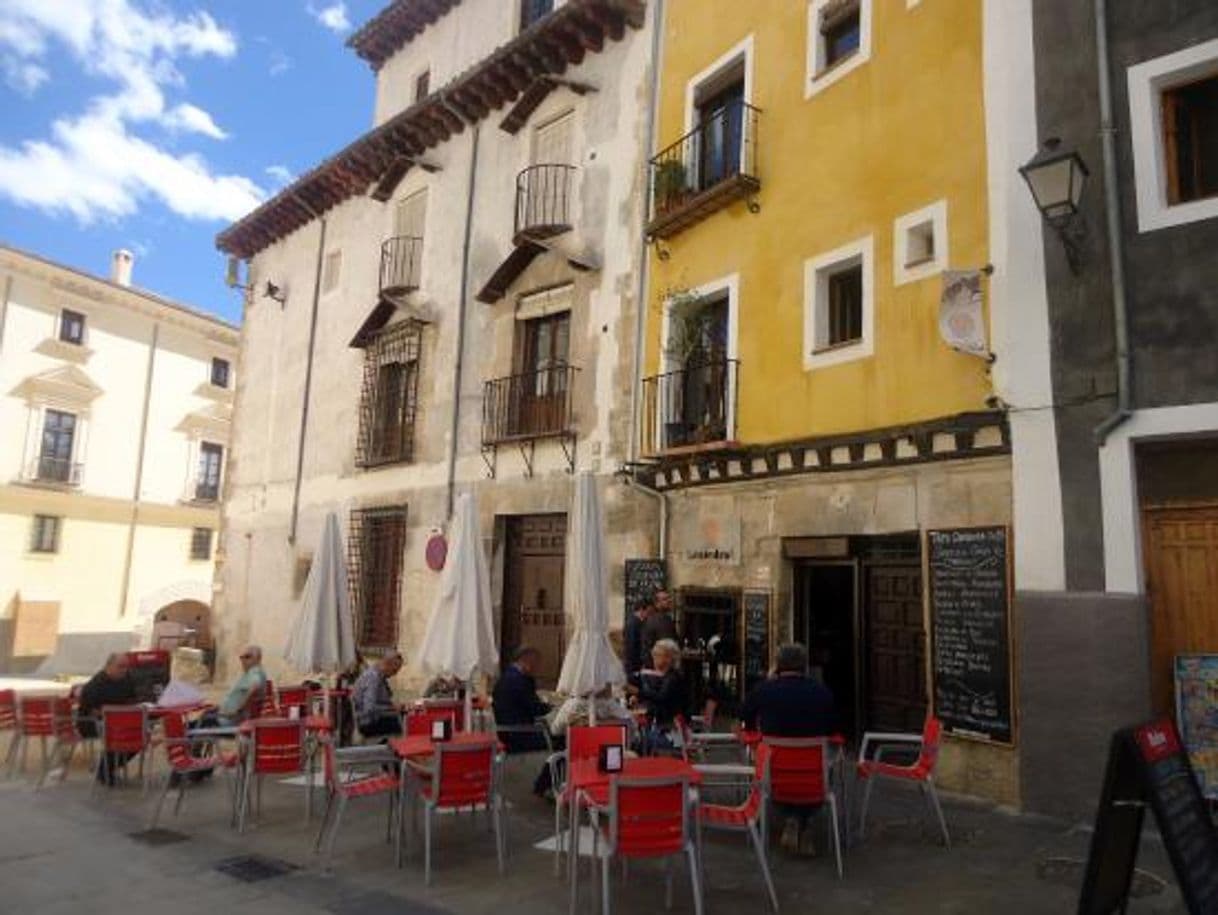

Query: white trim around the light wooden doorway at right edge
[[1100, 403, 1218, 595]]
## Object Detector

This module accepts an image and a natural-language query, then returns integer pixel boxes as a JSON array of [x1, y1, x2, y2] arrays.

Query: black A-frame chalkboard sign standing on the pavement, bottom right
[[1078, 719, 1218, 915]]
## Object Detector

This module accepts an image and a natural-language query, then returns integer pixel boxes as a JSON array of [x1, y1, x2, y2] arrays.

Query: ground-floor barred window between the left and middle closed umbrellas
[[347, 506, 406, 649]]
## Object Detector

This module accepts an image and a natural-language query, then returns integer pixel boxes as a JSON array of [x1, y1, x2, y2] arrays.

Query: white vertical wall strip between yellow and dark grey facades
[[982, 0, 1066, 591]]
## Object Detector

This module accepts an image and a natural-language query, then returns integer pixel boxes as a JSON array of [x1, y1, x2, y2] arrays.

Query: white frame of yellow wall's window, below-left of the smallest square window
[[804, 235, 876, 372]]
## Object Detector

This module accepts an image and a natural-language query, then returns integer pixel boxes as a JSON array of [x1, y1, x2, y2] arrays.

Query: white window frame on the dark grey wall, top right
[[1125, 38, 1218, 231]]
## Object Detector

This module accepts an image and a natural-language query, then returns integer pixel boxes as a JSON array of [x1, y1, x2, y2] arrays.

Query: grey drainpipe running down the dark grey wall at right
[[1095, 0, 1133, 446]]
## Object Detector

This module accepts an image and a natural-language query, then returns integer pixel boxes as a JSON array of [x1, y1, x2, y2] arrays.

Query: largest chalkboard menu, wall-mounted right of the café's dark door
[[927, 528, 1013, 743]]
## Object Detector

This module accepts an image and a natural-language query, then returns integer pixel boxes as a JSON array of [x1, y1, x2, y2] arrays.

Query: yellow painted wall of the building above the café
[[647, 0, 991, 443]]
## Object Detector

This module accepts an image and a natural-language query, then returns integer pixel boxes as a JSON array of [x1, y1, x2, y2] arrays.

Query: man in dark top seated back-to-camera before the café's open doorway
[[741, 645, 837, 854]]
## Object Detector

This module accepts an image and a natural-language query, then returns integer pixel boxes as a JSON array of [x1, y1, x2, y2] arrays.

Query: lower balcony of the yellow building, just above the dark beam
[[639, 359, 741, 454]]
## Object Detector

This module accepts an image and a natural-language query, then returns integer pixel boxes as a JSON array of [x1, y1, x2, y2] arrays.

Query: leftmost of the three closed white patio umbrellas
[[284, 512, 356, 674]]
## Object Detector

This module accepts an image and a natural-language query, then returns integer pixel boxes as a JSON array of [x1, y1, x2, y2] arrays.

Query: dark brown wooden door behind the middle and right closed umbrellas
[[499, 514, 566, 690]]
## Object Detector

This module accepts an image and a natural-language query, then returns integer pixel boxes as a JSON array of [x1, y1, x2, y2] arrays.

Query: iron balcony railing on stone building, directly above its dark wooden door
[[482, 363, 579, 446]]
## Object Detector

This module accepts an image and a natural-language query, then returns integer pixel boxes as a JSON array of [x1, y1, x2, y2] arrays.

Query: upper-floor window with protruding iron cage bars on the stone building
[[356, 320, 423, 467]]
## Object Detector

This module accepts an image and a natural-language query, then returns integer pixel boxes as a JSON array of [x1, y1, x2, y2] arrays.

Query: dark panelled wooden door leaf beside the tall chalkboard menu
[[864, 565, 927, 731]]
